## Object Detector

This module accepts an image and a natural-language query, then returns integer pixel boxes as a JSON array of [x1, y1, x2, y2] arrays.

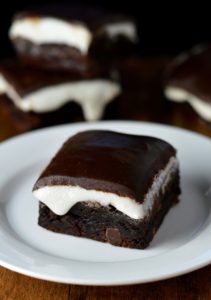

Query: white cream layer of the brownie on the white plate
[[33, 157, 178, 219]]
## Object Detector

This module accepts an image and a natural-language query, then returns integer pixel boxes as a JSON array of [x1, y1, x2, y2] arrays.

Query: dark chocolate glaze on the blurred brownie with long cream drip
[[0, 60, 112, 97]]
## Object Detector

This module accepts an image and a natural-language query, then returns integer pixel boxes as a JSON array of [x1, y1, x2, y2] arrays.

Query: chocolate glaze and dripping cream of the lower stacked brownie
[[0, 61, 120, 121]]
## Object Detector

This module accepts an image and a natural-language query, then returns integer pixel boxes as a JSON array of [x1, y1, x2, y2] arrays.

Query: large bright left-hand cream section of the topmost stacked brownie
[[9, 17, 92, 54]]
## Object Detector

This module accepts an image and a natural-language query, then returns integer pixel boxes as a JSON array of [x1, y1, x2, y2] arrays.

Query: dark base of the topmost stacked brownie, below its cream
[[13, 37, 134, 75]]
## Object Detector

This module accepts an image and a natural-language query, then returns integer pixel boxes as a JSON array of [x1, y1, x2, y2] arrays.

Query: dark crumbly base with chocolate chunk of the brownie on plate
[[38, 173, 180, 249]]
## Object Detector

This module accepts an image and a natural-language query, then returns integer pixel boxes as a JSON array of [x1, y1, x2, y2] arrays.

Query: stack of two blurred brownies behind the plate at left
[[0, 3, 138, 135]]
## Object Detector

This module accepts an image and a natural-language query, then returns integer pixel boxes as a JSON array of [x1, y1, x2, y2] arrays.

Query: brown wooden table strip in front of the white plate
[[0, 266, 211, 300]]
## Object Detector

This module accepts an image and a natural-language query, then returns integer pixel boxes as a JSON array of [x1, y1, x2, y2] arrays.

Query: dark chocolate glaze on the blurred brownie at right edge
[[165, 45, 211, 103]]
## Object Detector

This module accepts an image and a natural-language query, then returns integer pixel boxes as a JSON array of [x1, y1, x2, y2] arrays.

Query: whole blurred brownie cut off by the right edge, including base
[[164, 44, 211, 133]]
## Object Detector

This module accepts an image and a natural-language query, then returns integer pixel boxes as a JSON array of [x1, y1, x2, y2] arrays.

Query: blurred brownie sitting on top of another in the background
[[9, 4, 137, 71]]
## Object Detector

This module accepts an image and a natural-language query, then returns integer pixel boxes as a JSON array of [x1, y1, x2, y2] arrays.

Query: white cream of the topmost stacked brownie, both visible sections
[[9, 17, 137, 55]]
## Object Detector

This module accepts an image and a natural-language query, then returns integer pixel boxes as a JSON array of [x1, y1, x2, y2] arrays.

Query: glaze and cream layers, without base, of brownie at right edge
[[164, 45, 211, 122]]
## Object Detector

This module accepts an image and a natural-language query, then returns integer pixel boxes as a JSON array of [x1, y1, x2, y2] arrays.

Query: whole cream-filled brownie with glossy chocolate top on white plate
[[33, 130, 180, 249]]
